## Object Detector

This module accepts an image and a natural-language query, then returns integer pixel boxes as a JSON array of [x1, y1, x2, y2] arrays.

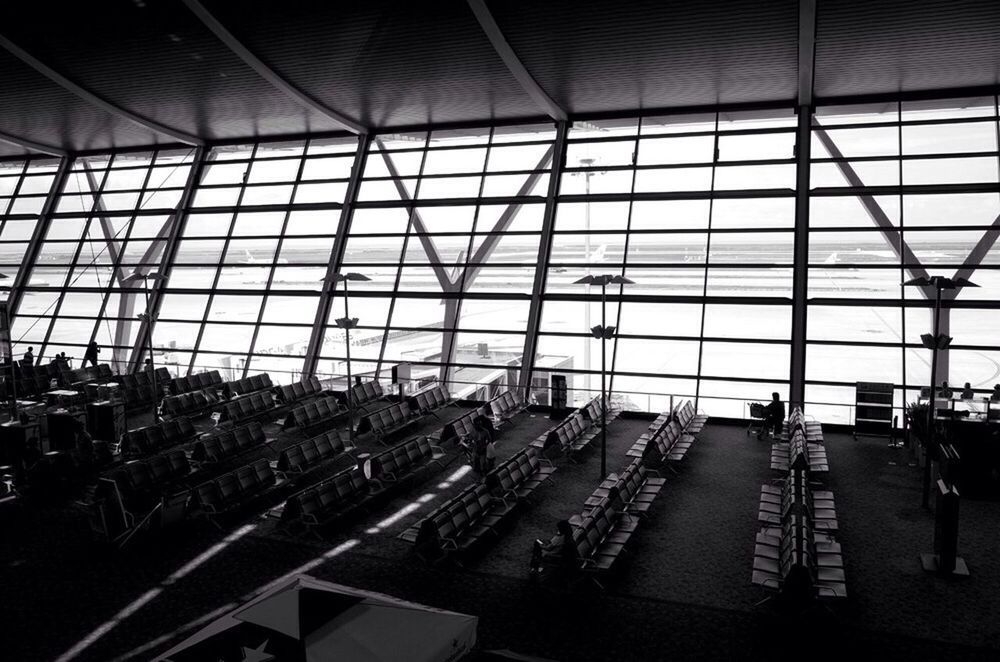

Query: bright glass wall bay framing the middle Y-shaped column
[[317, 124, 555, 398]]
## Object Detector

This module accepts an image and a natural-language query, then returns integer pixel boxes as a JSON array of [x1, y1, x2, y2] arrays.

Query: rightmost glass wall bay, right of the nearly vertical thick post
[[806, 97, 1000, 423]]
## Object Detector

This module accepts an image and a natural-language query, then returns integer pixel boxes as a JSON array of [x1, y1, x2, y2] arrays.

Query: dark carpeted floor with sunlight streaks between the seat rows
[[0, 415, 1000, 661]]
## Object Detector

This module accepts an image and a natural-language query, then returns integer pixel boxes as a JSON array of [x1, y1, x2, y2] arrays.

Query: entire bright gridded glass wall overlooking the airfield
[[0, 97, 1000, 423]]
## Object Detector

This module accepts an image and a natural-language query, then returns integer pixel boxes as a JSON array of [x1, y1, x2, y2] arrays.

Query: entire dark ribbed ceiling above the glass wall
[[0, 0, 1000, 156]]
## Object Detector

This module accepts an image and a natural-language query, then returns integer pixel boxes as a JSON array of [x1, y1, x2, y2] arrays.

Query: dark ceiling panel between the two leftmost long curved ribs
[[3, 0, 337, 139]]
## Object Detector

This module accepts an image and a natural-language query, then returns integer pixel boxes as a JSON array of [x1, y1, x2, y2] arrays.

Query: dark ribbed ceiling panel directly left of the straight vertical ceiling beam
[[489, 0, 798, 113]]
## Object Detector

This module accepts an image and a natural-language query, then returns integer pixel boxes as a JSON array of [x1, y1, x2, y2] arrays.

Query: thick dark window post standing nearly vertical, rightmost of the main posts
[[788, 105, 812, 408]]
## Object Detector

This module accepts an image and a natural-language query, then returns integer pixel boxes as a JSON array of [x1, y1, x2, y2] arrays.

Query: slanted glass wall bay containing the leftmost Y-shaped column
[[12, 150, 194, 371]]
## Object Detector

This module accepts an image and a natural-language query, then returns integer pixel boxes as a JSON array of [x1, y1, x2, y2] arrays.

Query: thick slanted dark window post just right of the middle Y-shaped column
[[518, 122, 569, 402]]
